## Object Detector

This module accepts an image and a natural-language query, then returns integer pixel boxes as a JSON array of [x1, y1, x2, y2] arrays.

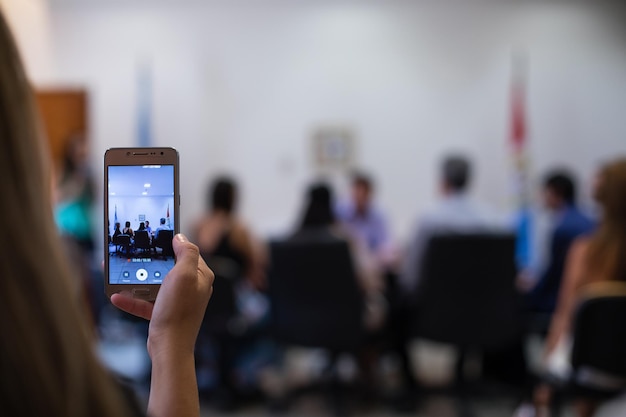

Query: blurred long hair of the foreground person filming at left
[[0, 11, 129, 417]]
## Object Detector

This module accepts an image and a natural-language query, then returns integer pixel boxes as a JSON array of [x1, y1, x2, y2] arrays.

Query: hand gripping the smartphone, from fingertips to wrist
[[111, 234, 214, 359]]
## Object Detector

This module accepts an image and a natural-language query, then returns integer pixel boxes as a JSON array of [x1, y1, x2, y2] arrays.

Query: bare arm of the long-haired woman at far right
[[545, 238, 590, 355]]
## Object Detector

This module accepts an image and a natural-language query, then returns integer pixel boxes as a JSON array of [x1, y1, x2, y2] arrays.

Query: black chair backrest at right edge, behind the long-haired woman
[[571, 283, 626, 379]]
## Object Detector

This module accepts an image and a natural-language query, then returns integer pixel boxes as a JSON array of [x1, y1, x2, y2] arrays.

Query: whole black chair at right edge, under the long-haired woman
[[571, 282, 626, 401]]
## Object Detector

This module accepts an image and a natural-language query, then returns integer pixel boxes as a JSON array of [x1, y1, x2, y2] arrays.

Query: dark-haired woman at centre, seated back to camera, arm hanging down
[[291, 183, 387, 330]]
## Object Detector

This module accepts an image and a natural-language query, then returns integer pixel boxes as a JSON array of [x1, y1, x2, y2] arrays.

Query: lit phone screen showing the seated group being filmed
[[107, 165, 176, 285]]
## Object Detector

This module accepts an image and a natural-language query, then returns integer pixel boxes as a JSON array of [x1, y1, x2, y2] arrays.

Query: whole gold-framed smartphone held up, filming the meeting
[[104, 148, 180, 301]]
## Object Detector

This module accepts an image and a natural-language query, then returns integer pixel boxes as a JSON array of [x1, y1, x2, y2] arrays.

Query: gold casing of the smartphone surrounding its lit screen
[[103, 147, 180, 301]]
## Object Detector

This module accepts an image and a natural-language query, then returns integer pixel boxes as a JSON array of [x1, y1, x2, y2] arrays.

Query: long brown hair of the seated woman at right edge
[[587, 158, 626, 281]]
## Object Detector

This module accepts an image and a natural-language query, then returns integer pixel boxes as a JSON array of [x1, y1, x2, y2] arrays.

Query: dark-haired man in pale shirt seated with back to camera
[[399, 155, 508, 293]]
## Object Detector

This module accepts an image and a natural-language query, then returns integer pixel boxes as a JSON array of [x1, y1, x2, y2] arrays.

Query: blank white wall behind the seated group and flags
[[4, 0, 626, 242]]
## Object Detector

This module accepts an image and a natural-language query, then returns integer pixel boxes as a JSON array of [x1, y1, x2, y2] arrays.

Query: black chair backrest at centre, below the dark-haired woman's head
[[268, 231, 364, 351]]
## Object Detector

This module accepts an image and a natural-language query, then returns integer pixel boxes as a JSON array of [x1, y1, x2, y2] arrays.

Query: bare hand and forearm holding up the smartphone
[[111, 235, 214, 417]]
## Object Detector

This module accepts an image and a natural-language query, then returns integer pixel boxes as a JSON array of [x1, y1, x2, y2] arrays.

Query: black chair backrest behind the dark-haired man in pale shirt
[[413, 233, 522, 348]]
